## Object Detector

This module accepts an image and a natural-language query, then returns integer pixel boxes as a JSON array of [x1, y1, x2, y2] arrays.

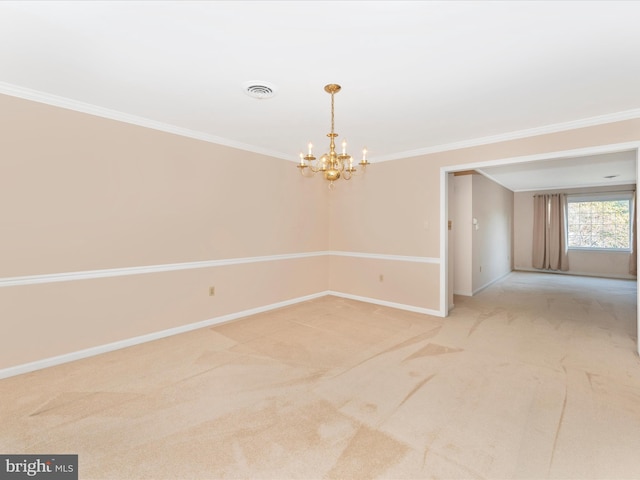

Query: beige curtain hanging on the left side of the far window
[[532, 194, 569, 271]]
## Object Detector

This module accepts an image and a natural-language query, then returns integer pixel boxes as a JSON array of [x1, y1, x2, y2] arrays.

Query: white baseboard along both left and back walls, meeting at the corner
[[0, 290, 444, 379]]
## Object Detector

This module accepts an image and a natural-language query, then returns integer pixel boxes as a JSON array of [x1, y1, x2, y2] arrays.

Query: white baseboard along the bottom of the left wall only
[[0, 292, 328, 379]]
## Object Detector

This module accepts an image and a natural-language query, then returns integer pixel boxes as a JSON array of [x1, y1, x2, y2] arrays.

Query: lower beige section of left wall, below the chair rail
[[0, 257, 328, 368]]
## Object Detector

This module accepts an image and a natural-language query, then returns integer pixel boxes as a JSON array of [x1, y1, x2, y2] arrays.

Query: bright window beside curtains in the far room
[[567, 193, 631, 250]]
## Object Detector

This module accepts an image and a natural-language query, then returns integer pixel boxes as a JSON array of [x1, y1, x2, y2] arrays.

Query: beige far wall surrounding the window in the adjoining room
[[514, 185, 635, 278]]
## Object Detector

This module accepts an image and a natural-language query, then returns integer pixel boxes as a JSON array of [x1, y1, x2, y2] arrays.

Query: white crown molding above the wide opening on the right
[[374, 112, 640, 163]]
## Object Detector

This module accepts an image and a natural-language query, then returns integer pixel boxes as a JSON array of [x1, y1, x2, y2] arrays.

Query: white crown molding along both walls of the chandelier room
[[0, 82, 640, 163]]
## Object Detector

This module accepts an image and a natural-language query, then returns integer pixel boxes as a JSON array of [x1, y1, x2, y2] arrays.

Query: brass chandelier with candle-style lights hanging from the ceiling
[[298, 83, 369, 189]]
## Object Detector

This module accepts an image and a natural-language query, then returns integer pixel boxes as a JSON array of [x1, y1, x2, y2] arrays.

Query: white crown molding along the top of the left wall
[[0, 82, 291, 160]]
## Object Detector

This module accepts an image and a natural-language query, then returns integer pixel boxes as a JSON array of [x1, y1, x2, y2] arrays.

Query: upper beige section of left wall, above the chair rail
[[0, 96, 328, 277]]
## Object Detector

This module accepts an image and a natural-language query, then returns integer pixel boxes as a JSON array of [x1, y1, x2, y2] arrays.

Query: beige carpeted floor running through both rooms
[[0, 273, 640, 480]]
